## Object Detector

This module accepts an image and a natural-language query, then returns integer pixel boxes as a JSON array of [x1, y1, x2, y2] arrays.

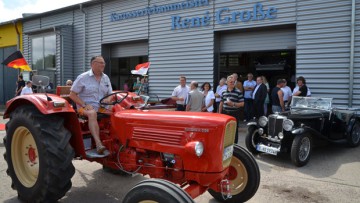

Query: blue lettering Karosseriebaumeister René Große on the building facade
[[110, 0, 278, 30]]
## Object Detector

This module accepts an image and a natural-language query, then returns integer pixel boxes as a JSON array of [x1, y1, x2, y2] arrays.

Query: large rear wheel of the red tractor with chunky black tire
[[4, 106, 75, 202]]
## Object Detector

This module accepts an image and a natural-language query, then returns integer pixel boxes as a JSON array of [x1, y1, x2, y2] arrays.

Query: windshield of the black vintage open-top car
[[291, 96, 332, 110]]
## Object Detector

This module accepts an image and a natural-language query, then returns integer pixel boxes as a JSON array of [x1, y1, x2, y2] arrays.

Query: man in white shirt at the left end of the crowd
[[171, 76, 190, 111]]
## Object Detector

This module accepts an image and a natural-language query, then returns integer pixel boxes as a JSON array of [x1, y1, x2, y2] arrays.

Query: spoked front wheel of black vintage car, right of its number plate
[[291, 134, 312, 167]]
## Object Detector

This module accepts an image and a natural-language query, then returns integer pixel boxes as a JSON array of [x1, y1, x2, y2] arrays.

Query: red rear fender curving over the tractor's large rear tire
[[3, 94, 76, 119]]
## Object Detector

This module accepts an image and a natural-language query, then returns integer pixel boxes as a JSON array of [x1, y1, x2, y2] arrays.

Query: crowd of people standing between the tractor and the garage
[[171, 73, 311, 140]]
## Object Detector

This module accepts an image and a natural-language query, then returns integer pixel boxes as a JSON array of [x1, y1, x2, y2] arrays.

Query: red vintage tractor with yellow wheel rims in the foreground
[[4, 76, 260, 203]]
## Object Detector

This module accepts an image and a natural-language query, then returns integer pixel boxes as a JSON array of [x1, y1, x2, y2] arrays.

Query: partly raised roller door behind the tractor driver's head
[[111, 42, 149, 58]]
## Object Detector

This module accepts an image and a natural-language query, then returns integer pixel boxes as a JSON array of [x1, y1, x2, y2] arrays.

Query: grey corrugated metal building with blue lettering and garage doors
[[23, 0, 360, 107]]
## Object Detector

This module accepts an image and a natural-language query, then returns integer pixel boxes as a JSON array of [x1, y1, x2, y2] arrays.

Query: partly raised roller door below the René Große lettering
[[220, 29, 296, 53]]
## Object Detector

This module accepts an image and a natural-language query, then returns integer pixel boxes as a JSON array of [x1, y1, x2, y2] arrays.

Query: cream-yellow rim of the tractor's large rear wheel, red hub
[[11, 127, 40, 188]]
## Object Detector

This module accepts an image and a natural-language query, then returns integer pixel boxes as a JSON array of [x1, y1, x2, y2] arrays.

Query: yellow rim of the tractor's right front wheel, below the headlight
[[229, 156, 248, 195]]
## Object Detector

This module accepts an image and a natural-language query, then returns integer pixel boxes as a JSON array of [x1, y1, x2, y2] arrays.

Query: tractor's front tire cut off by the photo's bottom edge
[[123, 179, 194, 203]]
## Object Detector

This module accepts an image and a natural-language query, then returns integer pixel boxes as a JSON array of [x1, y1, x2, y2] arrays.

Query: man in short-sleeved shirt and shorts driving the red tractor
[[70, 56, 112, 154]]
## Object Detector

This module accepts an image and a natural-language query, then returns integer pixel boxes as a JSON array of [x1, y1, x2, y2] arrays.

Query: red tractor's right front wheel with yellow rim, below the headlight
[[208, 145, 260, 203]]
